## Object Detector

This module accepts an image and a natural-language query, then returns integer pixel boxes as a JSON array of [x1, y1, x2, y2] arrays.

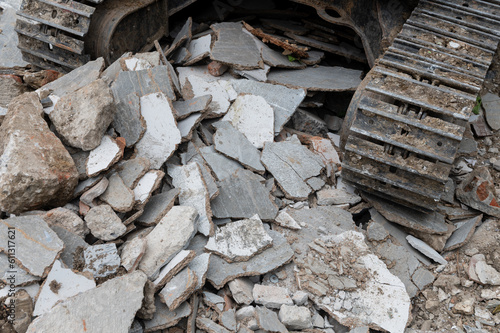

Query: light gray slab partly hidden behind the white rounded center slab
[[231, 80, 306, 134]]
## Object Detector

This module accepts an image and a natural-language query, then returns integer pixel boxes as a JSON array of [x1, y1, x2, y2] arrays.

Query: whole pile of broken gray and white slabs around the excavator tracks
[[0, 3, 500, 333]]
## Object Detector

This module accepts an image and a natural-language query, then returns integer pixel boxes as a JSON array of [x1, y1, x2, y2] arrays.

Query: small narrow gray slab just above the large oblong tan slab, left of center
[[137, 188, 179, 226]]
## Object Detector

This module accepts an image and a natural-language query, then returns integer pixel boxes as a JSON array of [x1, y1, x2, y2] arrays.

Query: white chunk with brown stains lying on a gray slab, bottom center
[[205, 216, 273, 263]]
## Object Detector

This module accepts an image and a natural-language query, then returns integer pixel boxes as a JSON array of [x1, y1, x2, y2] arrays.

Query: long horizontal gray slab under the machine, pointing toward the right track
[[267, 66, 362, 91]]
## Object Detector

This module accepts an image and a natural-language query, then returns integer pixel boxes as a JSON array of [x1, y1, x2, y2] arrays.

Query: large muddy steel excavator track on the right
[[341, 0, 500, 211]]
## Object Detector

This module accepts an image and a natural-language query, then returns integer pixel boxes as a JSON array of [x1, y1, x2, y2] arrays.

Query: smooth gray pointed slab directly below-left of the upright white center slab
[[213, 121, 266, 173]]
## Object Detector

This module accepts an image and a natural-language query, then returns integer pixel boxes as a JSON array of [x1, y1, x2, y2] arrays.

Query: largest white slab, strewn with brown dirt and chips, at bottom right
[[300, 231, 411, 332]]
